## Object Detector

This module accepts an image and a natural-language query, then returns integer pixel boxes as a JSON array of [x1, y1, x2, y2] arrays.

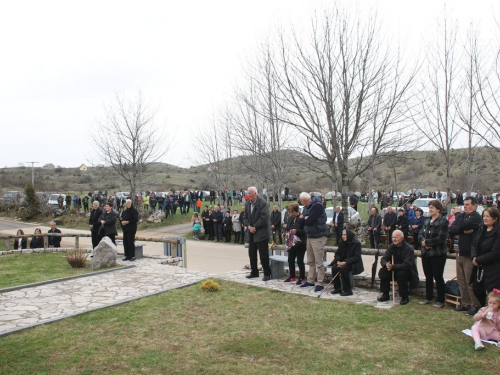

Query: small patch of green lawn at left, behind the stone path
[[0, 253, 97, 290]]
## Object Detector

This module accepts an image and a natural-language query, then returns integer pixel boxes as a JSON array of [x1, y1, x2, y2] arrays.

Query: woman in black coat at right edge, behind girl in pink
[[471, 207, 500, 306]]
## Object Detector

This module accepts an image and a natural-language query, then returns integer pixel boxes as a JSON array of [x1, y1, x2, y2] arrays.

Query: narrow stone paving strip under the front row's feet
[[217, 269, 401, 309]]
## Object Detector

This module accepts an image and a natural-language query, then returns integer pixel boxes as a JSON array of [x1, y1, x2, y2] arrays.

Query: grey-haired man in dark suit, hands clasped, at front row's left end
[[243, 186, 271, 281]]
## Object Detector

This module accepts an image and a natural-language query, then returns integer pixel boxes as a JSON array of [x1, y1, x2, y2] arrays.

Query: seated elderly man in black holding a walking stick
[[377, 230, 418, 305]]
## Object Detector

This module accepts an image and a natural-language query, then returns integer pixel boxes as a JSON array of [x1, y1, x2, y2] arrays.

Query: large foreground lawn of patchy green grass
[[0, 281, 494, 374]]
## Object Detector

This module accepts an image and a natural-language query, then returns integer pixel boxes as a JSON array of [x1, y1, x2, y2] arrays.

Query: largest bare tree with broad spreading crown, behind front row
[[279, 8, 414, 211]]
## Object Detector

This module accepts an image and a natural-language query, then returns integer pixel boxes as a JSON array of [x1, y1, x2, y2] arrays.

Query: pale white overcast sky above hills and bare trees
[[0, 0, 500, 167]]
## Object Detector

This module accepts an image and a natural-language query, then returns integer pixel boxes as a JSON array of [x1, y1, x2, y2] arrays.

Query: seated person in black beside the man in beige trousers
[[330, 229, 365, 297]]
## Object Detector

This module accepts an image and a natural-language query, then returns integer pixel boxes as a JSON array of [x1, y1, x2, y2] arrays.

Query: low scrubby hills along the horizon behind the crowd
[[0, 147, 500, 194]]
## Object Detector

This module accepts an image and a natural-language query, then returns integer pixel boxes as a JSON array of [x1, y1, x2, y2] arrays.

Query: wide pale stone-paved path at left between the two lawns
[[0, 258, 214, 336]]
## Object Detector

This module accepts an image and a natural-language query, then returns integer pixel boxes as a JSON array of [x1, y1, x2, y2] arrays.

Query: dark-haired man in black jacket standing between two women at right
[[449, 197, 483, 315]]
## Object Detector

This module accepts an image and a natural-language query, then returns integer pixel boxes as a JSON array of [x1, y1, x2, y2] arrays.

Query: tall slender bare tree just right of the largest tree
[[413, 17, 461, 210]]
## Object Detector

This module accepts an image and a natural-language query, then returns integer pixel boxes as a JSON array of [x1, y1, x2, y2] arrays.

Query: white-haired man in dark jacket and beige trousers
[[300, 192, 328, 292]]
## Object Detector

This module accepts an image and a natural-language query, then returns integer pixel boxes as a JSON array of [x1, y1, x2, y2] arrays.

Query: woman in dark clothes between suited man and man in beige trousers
[[283, 203, 307, 285]]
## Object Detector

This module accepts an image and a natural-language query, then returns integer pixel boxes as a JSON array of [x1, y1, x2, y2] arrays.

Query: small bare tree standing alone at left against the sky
[[92, 92, 169, 194]]
